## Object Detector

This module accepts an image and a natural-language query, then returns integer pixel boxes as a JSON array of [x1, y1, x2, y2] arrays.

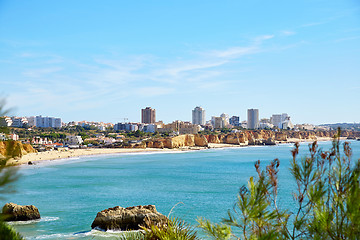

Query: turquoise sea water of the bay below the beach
[[1, 141, 360, 239]]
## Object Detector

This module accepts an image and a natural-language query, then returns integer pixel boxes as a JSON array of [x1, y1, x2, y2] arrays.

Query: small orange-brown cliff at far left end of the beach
[[0, 140, 36, 158]]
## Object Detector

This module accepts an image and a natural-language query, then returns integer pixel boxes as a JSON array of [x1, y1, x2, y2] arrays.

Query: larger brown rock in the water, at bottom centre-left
[[91, 205, 168, 231]]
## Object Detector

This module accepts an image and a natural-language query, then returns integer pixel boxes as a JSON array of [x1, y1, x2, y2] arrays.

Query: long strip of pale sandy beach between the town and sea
[[8, 137, 345, 166]]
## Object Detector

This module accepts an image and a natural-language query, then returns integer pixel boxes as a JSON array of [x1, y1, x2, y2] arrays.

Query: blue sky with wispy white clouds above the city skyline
[[0, 0, 360, 124]]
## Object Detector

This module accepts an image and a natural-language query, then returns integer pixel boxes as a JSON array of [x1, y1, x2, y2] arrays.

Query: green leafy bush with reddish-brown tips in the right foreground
[[198, 130, 360, 240]]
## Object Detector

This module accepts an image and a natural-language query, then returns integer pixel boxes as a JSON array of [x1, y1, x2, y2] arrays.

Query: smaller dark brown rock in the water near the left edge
[[2, 203, 40, 221]]
